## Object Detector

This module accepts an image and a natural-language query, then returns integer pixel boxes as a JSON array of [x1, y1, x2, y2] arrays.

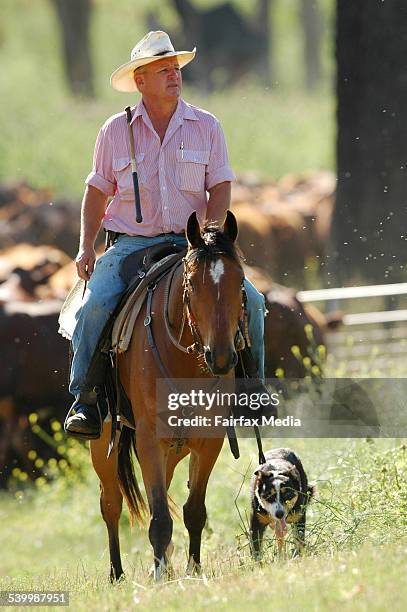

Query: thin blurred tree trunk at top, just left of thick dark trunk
[[300, 0, 322, 90]]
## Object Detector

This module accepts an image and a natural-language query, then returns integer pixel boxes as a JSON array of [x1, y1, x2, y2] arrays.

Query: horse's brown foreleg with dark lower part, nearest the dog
[[184, 438, 223, 574]]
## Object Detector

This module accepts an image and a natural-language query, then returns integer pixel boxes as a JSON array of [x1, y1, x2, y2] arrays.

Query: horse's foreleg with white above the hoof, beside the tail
[[136, 432, 172, 581]]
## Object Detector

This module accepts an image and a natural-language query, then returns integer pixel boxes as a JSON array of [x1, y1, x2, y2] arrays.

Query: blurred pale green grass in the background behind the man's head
[[0, 0, 334, 200]]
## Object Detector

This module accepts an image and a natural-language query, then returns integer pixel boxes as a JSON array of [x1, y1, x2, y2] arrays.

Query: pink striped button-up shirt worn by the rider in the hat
[[85, 99, 235, 236]]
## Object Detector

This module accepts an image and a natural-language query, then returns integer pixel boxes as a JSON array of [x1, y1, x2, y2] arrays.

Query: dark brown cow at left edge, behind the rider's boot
[[0, 300, 71, 487]]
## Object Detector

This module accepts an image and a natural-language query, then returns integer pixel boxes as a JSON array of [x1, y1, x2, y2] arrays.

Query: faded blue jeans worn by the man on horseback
[[69, 235, 266, 397]]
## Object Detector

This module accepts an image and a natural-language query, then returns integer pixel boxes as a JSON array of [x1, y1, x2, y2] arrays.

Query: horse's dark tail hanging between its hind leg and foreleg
[[118, 427, 147, 526]]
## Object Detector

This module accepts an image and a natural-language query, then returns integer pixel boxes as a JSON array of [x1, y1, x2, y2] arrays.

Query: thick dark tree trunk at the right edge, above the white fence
[[332, 0, 407, 282]]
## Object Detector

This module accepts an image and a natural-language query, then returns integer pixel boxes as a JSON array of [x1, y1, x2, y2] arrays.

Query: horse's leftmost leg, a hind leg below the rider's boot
[[90, 423, 123, 582]]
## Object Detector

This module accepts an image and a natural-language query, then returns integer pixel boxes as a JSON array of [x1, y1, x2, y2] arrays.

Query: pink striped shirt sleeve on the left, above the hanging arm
[[85, 125, 116, 196]]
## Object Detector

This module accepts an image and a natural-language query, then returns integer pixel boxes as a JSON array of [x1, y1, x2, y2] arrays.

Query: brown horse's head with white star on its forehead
[[184, 211, 244, 375]]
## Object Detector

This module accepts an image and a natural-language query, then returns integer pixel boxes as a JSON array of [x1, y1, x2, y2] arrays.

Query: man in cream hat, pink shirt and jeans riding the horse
[[65, 32, 265, 438]]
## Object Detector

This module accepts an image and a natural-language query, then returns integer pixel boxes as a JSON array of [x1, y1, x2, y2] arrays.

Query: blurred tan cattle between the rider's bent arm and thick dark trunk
[[232, 172, 335, 288]]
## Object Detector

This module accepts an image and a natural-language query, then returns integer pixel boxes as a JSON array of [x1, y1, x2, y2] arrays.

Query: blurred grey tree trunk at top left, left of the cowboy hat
[[52, 0, 94, 97]]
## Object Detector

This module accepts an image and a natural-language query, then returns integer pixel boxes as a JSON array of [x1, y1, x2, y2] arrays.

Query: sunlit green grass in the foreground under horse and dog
[[0, 439, 407, 610]]
